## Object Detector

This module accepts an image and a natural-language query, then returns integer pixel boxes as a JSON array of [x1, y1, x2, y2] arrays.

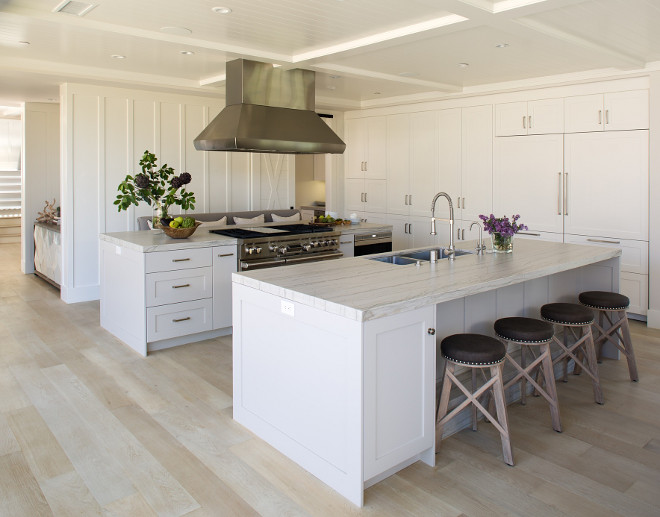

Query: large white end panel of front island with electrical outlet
[[233, 282, 364, 506]]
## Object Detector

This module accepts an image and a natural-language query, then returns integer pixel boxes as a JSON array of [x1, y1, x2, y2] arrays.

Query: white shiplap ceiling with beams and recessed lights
[[0, 0, 660, 109]]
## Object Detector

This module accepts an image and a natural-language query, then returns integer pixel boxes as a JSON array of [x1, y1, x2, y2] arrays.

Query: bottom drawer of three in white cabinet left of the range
[[147, 298, 213, 343]]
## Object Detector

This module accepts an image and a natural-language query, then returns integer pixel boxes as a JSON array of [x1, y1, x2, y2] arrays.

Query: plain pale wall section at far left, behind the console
[[21, 102, 61, 274]]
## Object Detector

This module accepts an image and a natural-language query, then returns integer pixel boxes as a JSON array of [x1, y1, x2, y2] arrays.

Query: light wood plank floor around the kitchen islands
[[0, 244, 660, 517]]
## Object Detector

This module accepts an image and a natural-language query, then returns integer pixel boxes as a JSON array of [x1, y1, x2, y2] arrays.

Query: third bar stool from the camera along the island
[[541, 303, 603, 404]]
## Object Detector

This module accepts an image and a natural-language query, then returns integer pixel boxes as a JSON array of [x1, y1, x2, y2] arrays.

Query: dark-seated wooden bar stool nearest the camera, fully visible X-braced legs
[[435, 334, 513, 465]]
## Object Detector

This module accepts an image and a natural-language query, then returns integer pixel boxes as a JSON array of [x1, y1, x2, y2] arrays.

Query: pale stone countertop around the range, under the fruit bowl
[[99, 222, 392, 253]]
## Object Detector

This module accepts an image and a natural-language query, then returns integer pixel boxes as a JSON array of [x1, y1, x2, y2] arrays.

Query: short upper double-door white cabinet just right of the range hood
[[346, 117, 387, 179]]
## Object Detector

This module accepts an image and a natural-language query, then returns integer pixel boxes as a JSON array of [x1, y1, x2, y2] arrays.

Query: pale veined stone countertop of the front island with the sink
[[233, 239, 621, 321]]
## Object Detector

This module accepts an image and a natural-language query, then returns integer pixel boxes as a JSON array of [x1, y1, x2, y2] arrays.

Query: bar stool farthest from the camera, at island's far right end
[[578, 291, 639, 382]]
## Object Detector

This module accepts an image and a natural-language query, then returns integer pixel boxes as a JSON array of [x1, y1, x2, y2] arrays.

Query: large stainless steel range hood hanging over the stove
[[194, 59, 346, 154]]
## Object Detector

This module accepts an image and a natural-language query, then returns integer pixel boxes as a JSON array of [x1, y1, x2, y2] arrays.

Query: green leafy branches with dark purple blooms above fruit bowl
[[114, 150, 195, 212]]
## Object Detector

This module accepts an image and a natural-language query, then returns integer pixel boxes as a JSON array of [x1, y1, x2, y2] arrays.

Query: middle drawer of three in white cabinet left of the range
[[147, 267, 213, 307]]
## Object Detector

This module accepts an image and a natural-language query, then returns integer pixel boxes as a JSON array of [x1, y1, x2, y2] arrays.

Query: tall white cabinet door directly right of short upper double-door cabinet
[[387, 113, 410, 215]]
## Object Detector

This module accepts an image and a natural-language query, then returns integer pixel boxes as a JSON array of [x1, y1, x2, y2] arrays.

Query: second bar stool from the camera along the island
[[493, 317, 561, 433]]
